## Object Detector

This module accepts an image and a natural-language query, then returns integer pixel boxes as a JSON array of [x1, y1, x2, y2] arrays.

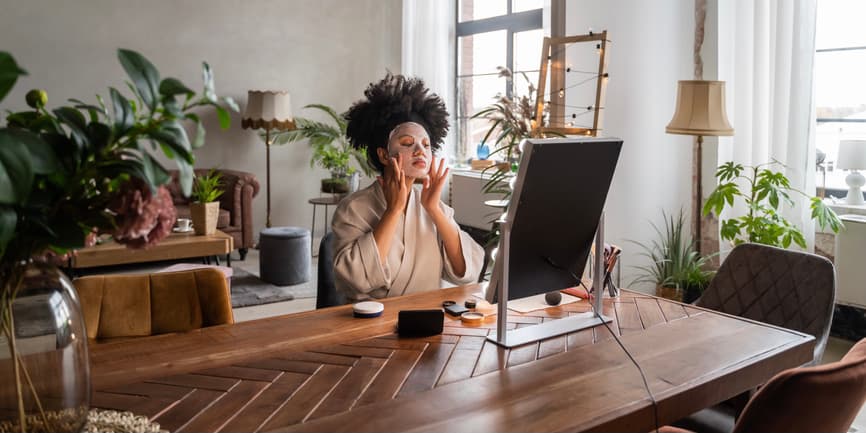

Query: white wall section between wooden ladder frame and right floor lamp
[[566, 0, 696, 292]]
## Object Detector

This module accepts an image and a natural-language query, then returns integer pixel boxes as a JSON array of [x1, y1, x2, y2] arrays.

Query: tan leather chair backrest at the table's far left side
[[75, 268, 234, 339]]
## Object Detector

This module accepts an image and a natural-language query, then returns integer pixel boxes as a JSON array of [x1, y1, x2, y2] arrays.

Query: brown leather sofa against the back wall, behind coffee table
[[168, 169, 259, 260]]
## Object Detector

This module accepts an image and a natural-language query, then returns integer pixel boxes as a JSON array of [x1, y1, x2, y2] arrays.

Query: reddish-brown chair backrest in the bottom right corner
[[734, 339, 866, 433]]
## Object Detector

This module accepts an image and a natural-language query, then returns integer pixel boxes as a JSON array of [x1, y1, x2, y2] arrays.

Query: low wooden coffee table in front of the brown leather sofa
[[70, 230, 234, 269]]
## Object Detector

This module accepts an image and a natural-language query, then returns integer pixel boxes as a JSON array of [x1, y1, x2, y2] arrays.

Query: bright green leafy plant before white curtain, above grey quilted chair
[[703, 161, 842, 248]]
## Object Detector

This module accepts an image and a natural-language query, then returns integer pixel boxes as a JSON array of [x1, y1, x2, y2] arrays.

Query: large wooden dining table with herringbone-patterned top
[[91, 285, 814, 432]]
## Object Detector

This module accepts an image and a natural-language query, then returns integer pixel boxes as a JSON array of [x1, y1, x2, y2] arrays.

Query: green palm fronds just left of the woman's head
[[274, 104, 375, 176]]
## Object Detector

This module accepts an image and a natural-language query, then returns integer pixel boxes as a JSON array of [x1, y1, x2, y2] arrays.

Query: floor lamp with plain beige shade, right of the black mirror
[[665, 80, 734, 254]]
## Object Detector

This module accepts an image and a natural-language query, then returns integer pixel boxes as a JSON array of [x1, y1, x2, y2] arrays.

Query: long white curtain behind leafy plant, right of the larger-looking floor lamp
[[718, 0, 816, 250]]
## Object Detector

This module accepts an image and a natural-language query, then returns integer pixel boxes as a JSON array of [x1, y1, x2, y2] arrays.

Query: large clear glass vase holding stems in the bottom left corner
[[0, 263, 90, 432]]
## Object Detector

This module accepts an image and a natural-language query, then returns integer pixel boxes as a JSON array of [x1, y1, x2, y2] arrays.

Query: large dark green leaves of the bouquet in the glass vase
[[0, 49, 236, 262]]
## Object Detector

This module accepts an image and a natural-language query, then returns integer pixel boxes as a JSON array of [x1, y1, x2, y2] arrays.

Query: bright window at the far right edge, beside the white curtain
[[814, 0, 866, 196]]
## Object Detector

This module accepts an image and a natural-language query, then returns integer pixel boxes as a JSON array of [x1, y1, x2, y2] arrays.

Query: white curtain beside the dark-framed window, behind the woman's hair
[[401, 0, 457, 155]]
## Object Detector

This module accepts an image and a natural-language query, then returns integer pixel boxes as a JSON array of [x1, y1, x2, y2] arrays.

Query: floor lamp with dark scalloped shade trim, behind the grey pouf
[[241, 90, 295, 227]]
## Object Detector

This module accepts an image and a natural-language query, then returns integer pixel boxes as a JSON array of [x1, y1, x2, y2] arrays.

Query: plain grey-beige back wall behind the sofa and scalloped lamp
[[0, 0, 402, 240]]
